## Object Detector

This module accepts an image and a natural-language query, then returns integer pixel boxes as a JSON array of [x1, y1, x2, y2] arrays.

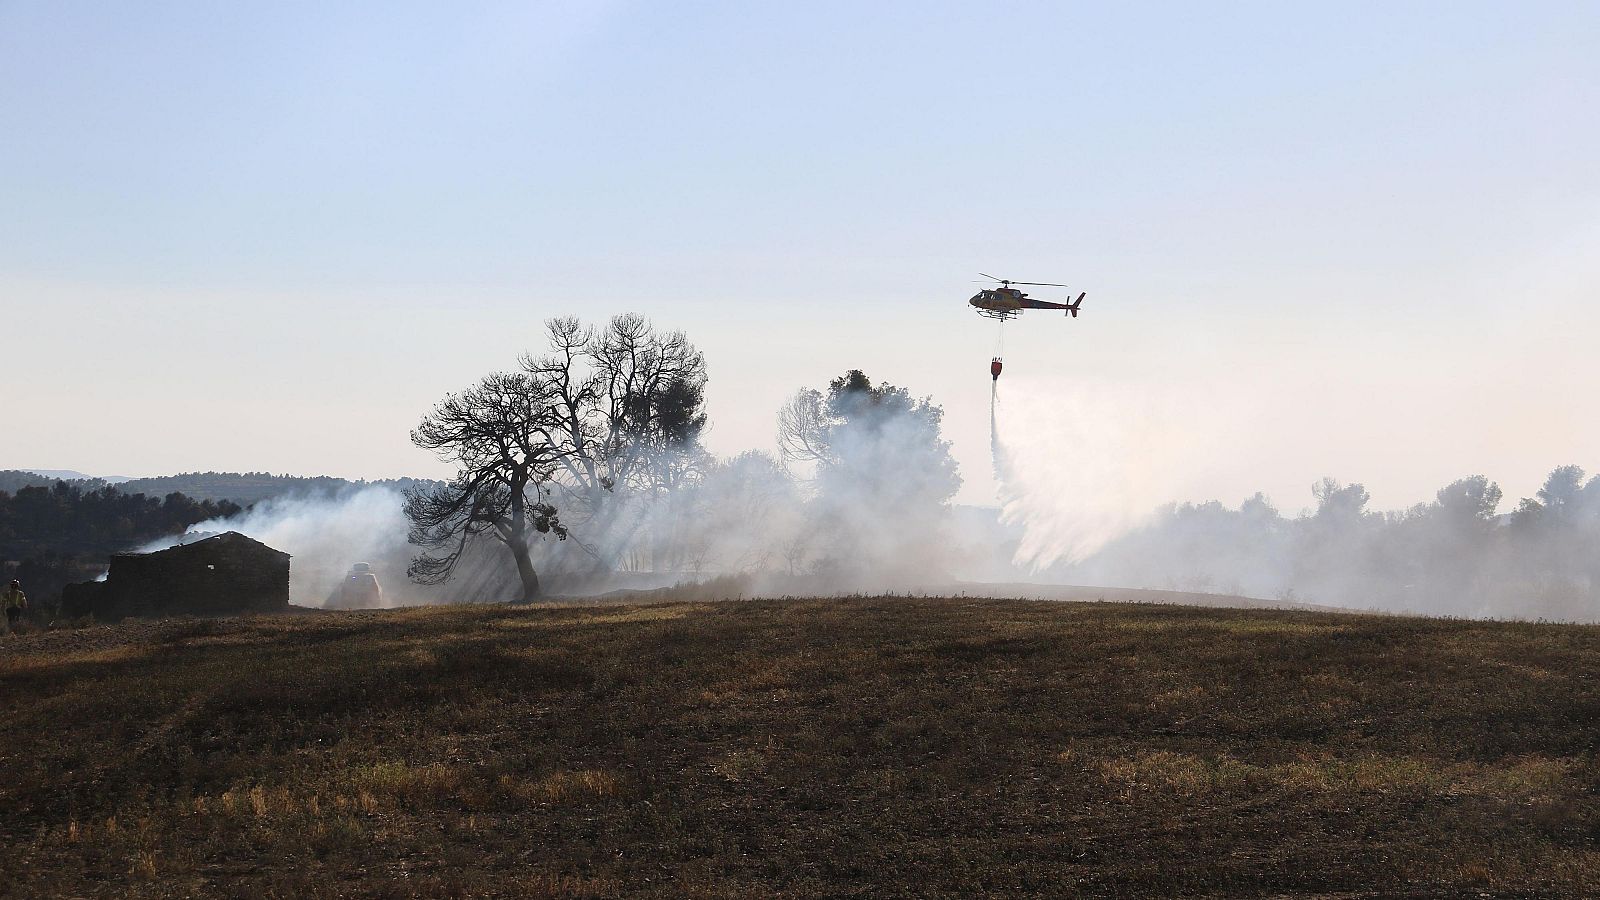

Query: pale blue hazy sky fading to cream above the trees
[[0, 0, 1600, 511]]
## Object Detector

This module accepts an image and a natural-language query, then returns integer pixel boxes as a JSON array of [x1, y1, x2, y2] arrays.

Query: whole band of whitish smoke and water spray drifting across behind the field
[[131, 368, 1600, 620]]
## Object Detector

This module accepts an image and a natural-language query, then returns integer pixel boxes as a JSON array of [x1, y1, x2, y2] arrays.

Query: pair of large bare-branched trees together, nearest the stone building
[[405, 315, 706, 599]]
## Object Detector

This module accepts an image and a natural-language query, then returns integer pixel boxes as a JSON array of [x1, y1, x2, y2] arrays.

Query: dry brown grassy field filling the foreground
[[0, 597, 1600, 897]]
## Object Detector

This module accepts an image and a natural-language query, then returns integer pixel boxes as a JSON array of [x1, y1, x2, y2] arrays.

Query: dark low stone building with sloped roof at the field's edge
[[61, 532, 290, 621]]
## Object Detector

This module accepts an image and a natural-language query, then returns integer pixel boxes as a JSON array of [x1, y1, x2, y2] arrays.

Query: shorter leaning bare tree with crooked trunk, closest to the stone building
[[405, 372, 573, 602]]
